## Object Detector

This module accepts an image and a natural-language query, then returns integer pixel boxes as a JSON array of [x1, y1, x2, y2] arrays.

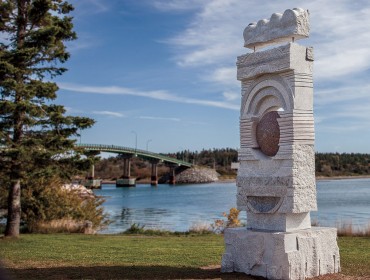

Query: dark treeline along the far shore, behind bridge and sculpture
[[95, 148, 370, 179]]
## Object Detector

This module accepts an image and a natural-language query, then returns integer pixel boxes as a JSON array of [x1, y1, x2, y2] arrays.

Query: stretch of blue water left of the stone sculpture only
[[94, 183, 245, 233]]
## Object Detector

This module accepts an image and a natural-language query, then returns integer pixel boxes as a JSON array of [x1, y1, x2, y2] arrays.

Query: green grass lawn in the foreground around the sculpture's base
[[0, 234, 370, 279]]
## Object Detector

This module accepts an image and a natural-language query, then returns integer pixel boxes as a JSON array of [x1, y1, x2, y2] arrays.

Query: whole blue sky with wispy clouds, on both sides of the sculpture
[[56, 0, 370, 153]]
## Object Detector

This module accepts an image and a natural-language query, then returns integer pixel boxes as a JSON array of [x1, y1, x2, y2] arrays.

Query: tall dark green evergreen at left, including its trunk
[[0, 0, 94, 237]]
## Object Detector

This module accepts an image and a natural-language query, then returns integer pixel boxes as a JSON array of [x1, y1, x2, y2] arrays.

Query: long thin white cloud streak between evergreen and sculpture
[[58, 83, 239, 110]]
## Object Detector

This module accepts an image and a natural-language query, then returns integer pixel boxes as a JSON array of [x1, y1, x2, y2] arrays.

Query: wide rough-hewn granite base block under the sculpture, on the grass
[[221, 227, 340, 280]]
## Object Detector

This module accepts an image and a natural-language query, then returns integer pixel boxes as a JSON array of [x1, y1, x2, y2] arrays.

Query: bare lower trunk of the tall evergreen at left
[[5, 179, 21, 237]]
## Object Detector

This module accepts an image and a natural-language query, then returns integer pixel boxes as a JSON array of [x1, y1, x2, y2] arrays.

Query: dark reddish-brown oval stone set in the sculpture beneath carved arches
[[256, 111, 280, 157]]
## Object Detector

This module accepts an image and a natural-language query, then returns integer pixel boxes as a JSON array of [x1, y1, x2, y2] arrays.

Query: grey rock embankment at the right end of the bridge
[[176, 167, 220, 184]]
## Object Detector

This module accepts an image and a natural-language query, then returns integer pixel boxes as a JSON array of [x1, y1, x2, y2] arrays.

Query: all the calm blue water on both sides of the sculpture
[[95, 179, 370, 233]]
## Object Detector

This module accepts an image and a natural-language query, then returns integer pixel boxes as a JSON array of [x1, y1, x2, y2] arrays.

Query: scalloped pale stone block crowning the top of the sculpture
[[243, 8, 310, 49]]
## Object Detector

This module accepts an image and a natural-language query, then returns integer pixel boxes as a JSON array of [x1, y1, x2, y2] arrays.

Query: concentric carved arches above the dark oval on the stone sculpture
[[241, 75, 294, 119]]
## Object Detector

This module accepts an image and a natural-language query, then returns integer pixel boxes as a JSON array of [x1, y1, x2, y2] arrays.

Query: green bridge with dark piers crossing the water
[[76, 144, 193, 186]]
